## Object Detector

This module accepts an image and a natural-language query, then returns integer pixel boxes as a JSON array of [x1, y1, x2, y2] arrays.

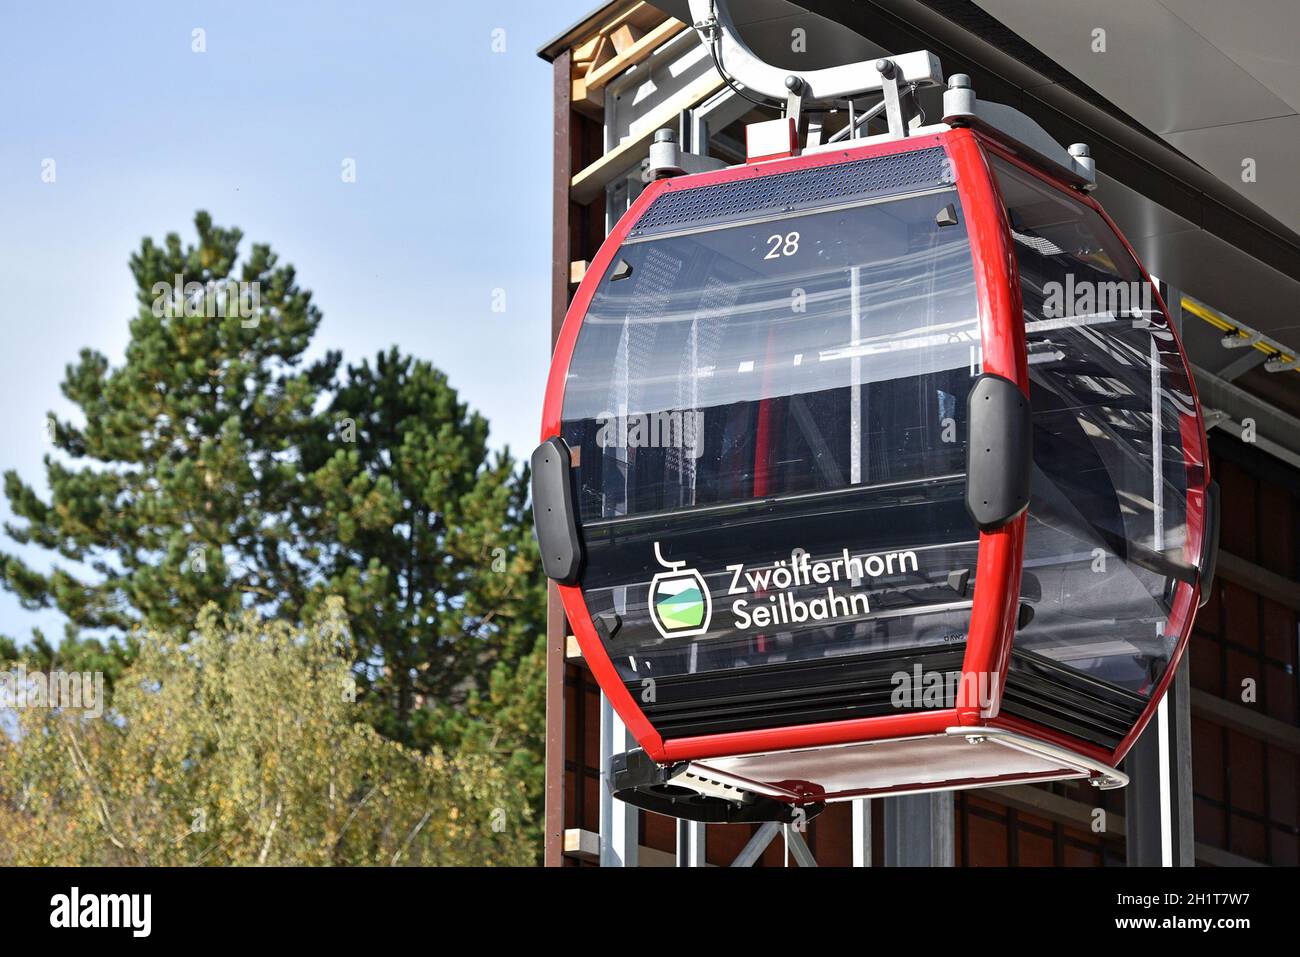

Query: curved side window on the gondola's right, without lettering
[[993, 157, 1201, 696]]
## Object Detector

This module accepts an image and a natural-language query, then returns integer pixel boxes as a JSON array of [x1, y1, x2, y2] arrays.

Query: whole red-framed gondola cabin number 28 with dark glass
[[533, 117, 1216, 820]]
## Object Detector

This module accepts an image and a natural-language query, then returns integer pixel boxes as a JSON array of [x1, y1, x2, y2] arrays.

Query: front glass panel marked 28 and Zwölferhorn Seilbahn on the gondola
[[562, 186, 979, 683]]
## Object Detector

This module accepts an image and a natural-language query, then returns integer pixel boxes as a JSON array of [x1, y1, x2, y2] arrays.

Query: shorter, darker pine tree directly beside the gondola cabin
[[302, 348, 546, 744]]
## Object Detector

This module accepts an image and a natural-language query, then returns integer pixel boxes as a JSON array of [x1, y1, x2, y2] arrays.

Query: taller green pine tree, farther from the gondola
[[0, 212, 339, 635]]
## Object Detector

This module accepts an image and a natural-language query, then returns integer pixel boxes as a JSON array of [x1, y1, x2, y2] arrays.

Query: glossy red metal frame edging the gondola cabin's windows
[[541, 129, 1209, 765]]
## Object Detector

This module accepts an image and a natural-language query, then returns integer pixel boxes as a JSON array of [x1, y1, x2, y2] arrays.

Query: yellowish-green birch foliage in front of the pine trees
[[0, 599, 536, 866]]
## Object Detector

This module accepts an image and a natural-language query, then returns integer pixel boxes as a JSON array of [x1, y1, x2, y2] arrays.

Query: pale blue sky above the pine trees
[[0, 0, 599, 638]]
